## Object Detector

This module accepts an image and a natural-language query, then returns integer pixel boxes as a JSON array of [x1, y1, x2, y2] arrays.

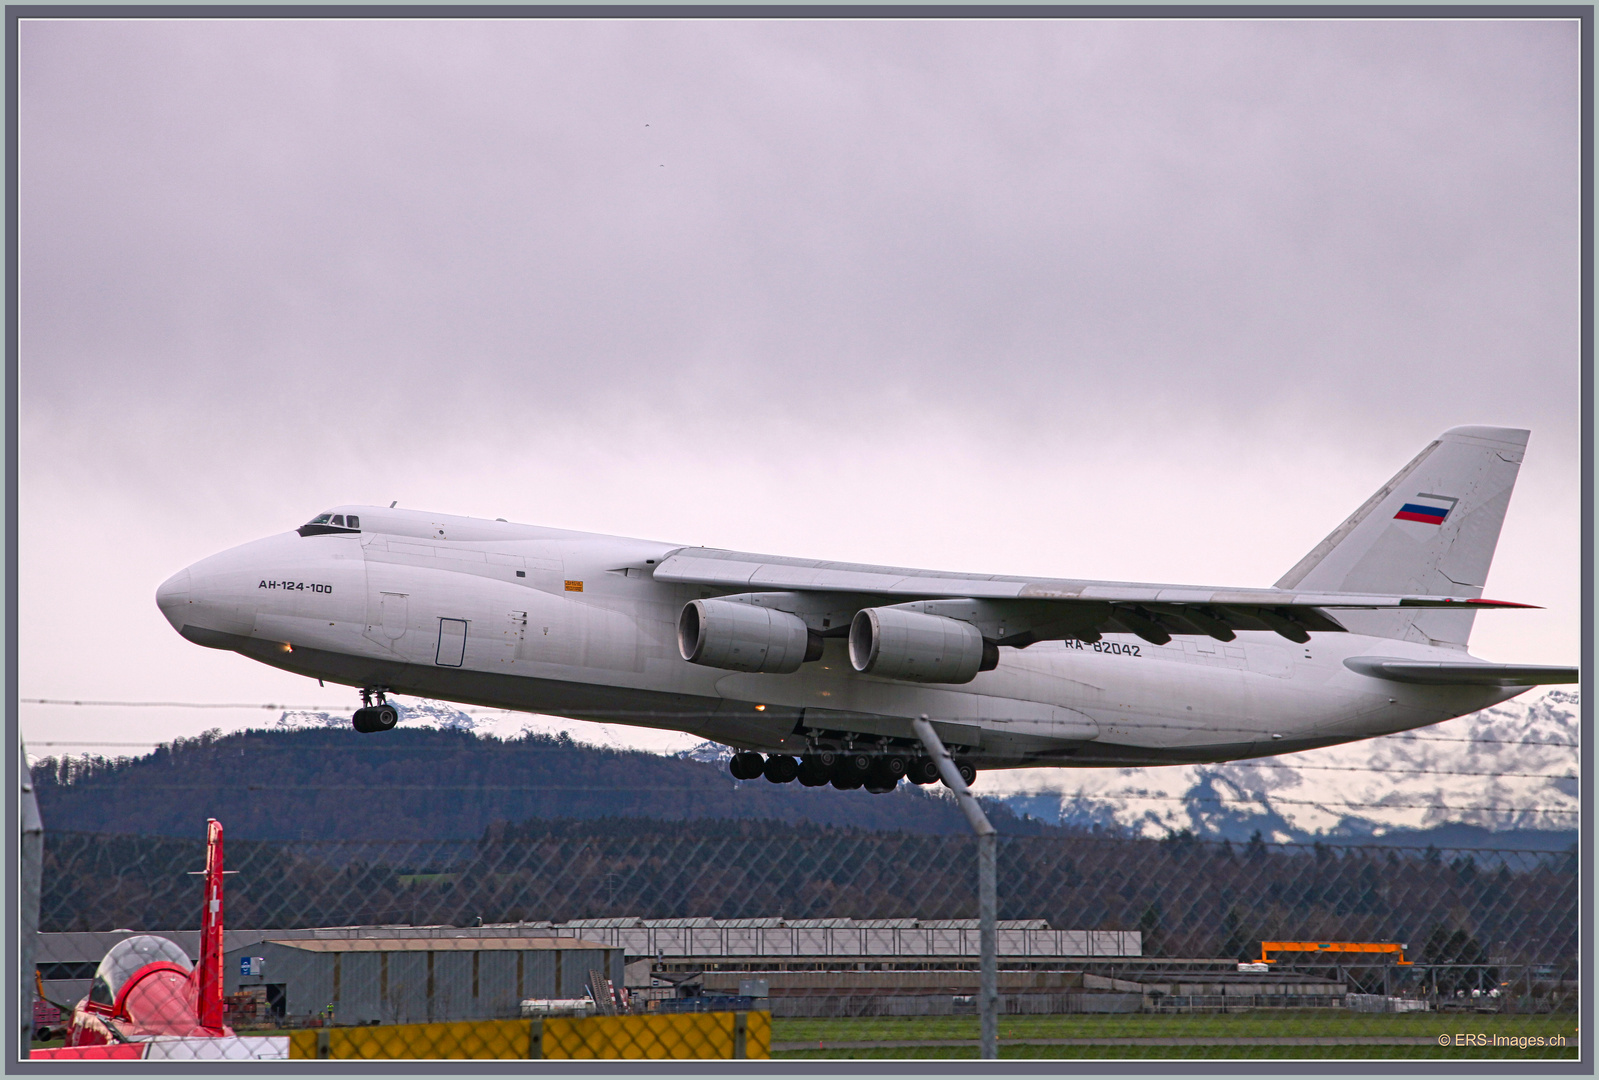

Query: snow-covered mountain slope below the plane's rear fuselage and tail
[[979, 690, 1580, 842]]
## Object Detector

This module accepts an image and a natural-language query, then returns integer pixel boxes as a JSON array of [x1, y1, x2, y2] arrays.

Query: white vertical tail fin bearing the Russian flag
[[1276, 427, 1529, 650]]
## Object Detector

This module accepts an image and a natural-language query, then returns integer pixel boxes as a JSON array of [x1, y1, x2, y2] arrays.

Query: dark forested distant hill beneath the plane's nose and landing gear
[[34, 728, 1054, 840]]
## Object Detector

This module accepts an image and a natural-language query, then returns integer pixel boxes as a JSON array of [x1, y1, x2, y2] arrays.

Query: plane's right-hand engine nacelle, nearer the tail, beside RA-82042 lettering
[[849, 608, 999, 683]]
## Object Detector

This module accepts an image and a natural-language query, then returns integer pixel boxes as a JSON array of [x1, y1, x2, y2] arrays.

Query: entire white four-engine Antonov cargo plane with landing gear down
[[155, 427, 1577, 792]]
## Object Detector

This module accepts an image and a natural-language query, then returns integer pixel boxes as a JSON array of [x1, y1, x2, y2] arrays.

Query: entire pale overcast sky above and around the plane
[[19, 12, 1580, 764]]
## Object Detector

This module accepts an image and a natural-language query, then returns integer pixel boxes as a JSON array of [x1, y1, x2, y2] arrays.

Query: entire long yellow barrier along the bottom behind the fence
[[289, 1013, 772, 1061]]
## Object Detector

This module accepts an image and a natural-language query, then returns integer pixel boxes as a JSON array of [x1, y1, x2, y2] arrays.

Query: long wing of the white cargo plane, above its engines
[[654, 547, 1530, 645]]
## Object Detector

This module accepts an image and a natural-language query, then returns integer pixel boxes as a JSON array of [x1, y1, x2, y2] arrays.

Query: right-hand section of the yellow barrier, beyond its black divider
[[540, 1013, 772, 1058]]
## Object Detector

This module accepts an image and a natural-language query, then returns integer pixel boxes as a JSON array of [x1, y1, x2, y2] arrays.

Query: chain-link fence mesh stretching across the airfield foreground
[[38, 819, 1578, 1058]]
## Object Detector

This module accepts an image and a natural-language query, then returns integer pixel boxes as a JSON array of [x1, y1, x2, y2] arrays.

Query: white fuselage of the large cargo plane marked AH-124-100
[[158, 507, 1525, 768]]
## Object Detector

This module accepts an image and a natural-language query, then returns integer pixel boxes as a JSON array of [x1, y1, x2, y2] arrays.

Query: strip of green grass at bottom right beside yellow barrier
[[772, 1010, 1578, 1061]]
